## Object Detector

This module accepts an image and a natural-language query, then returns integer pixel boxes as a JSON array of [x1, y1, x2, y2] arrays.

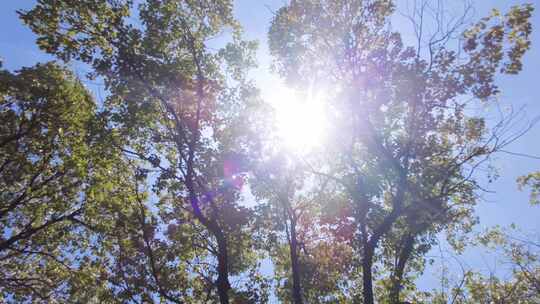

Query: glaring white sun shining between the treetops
[[271, 87, 327, 152]]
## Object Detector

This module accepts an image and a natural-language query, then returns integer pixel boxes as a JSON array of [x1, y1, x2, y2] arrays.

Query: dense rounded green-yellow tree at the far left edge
[[0, 63, 138, 302]]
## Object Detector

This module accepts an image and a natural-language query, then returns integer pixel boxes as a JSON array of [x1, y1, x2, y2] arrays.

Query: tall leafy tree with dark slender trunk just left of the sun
[[21, 0, 268, 303]]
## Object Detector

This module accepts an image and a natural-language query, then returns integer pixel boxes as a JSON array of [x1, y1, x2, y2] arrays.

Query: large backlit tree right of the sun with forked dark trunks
[[269, 0, 532, 303]]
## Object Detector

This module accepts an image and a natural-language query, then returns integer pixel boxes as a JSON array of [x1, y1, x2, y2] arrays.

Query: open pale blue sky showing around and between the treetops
[[0, 0, 540, 300]]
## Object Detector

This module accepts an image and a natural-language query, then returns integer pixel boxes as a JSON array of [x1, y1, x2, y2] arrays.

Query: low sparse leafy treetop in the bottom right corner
[[422, 227, 540, 303]]
